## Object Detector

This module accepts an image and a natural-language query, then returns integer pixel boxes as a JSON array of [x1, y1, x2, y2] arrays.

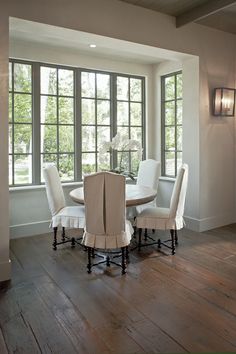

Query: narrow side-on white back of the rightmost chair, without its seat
[[170, 164, 188, 217]]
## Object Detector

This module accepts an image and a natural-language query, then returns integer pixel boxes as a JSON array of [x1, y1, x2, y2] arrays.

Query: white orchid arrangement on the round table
[[99, 133, 143, 179]]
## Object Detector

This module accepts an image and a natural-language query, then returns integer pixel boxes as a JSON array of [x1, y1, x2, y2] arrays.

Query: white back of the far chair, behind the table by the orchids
[[137, 159, 161, 190]]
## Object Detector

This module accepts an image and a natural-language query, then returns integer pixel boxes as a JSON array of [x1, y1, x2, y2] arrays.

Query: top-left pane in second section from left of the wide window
[[40, 66, 57, 95]]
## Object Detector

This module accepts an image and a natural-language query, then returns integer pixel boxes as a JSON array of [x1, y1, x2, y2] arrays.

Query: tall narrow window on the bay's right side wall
[[161, 72, 183, 177]]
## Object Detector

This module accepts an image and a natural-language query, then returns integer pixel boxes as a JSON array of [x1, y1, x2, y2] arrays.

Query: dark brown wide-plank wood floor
[[0, 225, 236, 354]]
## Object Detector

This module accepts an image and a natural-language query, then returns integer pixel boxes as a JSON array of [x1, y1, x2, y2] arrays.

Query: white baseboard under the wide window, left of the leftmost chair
[[10, 220, 51, 239]]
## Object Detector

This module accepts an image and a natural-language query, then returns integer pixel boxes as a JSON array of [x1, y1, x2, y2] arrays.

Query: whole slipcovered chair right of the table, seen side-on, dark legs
[[136, 164, 188, 254]]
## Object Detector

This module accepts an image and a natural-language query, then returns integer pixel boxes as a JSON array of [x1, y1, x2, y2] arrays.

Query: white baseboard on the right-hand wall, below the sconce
[[184, 213, 235, 232]]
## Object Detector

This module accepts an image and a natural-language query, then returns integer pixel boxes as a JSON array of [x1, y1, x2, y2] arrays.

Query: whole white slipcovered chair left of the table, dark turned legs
[[43, 165, 85, 250]]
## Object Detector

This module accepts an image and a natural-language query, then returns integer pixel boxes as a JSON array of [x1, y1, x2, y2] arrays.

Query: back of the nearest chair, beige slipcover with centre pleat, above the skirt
[[84, 172, 125, 236]]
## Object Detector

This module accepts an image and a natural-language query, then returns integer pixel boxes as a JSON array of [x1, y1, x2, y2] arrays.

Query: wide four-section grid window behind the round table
[[9, 60, 145, 186]]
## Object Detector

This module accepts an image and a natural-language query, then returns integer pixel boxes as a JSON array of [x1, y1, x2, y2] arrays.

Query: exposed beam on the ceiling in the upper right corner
[[176, 0, 236, 27]]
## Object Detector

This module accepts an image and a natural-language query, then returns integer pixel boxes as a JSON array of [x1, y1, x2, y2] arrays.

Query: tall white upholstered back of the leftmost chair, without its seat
[[43, 165, 66, 216]]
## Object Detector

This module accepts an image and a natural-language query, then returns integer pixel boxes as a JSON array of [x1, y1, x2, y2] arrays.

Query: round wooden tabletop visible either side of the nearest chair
[[70, 184, 157, 207]]
